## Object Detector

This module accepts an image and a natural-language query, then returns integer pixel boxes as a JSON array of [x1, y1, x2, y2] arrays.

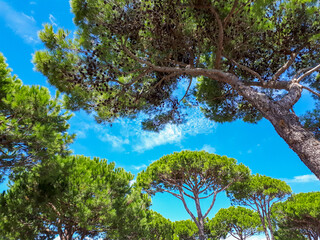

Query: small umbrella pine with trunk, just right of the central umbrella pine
[[228, 174, 291, 240]]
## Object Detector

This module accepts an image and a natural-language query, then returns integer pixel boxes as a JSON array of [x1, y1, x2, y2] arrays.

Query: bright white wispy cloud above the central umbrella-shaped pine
[[133, 110, 216, 152]]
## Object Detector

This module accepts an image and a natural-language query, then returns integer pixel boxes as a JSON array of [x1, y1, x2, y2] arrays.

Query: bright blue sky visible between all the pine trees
[[0, 0, 320, 231]]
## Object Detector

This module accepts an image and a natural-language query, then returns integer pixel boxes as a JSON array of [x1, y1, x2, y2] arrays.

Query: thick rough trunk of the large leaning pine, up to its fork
[[220, 76, 320, 179]]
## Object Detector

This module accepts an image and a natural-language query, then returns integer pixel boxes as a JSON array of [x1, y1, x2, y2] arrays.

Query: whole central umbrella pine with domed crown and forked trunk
[[137, 151, 250, 240]]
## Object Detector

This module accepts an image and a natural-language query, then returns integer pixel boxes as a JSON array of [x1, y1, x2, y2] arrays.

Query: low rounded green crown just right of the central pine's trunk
[[208, 207, 262, 240]]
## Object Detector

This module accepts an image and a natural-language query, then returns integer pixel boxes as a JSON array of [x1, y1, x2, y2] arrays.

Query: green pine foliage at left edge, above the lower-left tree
[[0, 54, 74, 174]]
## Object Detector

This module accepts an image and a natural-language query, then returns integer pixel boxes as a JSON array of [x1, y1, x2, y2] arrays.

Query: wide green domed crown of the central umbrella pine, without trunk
[[137, 151, 249, 195]]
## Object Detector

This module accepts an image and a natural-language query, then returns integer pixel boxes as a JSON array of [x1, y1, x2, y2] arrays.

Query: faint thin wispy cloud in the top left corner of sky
[[0, 0, 39, 44]]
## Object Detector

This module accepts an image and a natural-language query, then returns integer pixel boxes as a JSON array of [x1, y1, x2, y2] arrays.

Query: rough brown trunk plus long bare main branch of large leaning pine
[[146, 64, 320, 179]]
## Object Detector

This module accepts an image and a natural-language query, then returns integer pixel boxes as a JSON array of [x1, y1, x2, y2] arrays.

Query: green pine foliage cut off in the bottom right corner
[[273, 192, 320, 240]]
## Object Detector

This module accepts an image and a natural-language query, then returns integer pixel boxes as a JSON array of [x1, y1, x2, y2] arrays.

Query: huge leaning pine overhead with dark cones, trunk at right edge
[[34, 0, 320, 178]]
